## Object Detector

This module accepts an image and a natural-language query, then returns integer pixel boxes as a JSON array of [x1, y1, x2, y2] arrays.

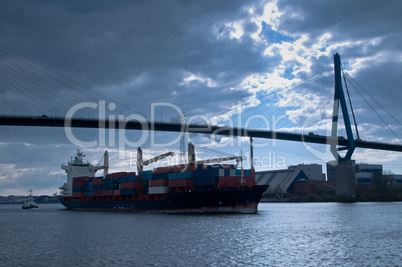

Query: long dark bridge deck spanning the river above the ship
[[0, 116, 402, 152]]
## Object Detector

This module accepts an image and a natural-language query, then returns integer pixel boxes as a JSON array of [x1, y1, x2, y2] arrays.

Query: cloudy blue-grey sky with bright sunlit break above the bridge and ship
[[0, 0, 402, 195]]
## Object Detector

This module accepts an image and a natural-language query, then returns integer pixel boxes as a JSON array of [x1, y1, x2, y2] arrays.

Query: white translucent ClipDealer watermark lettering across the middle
[[64, 101, 327, 163]]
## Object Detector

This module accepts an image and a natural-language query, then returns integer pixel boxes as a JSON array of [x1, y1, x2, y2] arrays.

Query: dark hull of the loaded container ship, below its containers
[[59, 185, 268, 213]]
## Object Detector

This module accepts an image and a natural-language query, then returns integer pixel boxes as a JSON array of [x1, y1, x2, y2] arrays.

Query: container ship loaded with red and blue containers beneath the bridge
[[58, 143, 268, 213]]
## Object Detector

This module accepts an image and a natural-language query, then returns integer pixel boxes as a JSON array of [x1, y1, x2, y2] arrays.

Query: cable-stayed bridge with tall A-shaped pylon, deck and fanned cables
[[0, 46, 402, 158]]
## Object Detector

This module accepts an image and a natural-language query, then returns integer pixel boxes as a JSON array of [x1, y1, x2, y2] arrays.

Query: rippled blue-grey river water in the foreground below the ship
[[0, 202, 402, 266]]
